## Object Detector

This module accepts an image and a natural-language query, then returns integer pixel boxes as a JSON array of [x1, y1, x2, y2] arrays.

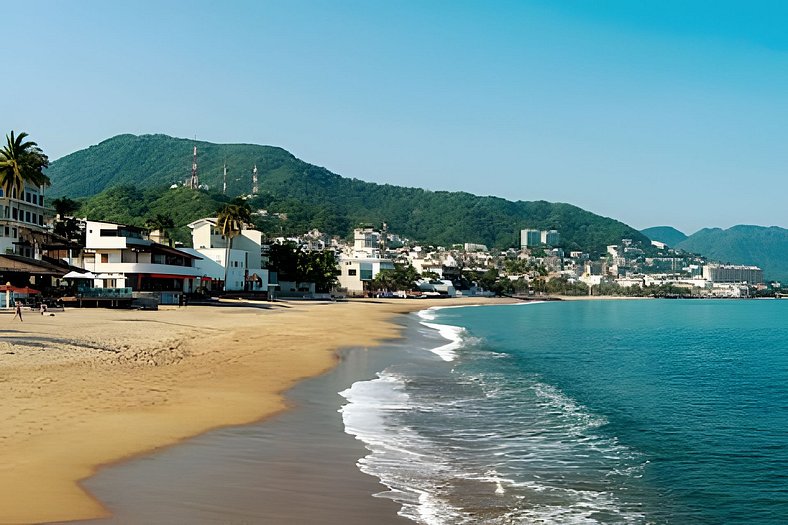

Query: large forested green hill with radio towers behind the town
[[47, 135, 648, 253]]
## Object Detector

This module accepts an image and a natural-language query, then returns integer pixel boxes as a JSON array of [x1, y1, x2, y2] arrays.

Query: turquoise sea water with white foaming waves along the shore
[[341, 300, 788, 525]]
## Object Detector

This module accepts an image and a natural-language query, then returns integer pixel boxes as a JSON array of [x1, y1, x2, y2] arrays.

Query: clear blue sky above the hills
[[0, 0, 788, 234]]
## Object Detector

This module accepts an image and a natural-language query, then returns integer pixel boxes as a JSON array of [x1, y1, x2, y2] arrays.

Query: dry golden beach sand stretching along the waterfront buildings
[[0, 299, 510, 523]]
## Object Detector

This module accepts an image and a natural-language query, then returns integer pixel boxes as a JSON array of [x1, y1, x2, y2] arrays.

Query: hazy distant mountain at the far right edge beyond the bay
[[675, 225, 788, 282]]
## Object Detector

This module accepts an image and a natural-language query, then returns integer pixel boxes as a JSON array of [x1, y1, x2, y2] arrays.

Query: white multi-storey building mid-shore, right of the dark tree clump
[[338, 228, 394, 295]]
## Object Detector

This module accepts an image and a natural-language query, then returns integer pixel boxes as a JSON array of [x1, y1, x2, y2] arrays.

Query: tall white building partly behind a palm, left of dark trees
[[181, 217, 269, 292]]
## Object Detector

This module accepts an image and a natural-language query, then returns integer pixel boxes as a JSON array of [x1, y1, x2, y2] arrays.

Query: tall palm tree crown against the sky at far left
[[0, 131, 50, 195]]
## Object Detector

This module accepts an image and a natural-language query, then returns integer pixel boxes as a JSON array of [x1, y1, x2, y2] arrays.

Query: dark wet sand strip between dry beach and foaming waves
[[72, 345, 412, 525]]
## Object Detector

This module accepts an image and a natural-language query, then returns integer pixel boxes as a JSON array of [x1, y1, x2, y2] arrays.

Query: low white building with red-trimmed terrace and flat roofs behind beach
[[79, 221, 201, 293]]
